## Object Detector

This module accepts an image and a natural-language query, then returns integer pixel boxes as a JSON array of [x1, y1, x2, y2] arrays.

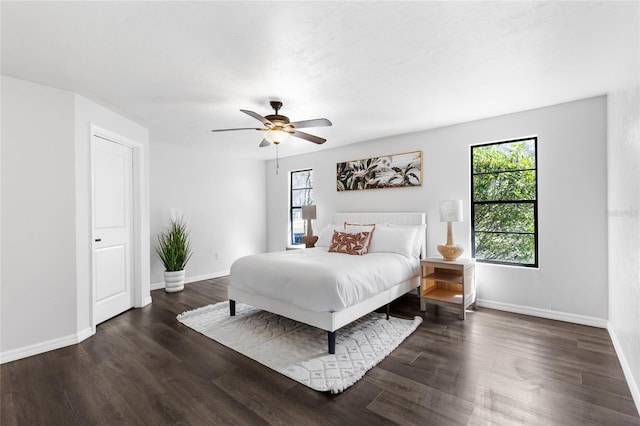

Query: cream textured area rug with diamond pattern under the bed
[[177, 301, 422, 393]]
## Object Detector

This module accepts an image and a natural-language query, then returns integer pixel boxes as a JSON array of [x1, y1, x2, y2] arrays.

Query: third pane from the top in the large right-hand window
[[474, 203, 535, 233]]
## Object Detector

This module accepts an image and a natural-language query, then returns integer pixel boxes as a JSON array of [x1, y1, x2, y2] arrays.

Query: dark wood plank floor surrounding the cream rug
[[0, 278, 640, 426]]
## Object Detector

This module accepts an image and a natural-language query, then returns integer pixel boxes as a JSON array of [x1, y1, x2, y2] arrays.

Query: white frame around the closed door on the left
[[89, 124, 150, 334]]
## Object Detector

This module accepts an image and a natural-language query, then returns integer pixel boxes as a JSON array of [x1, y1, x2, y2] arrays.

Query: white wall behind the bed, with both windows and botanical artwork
[[267, 97, 607, 327]]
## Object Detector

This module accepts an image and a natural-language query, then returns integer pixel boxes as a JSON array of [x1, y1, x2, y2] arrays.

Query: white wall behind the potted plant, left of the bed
[[151, 143, 266, 289]]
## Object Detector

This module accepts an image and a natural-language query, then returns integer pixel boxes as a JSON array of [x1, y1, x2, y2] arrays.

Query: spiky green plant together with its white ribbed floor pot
[[155, 220, 192, 293]]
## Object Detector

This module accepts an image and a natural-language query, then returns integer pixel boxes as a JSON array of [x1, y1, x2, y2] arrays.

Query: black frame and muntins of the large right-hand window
[[470, 136, 540, 268]]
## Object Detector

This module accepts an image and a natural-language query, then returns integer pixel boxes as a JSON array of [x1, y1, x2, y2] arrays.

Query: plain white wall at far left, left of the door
[[0, 76, 76, 353]]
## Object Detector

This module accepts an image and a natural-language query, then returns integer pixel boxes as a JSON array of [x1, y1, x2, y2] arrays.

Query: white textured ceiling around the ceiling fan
[[1, 1, 639, 159]]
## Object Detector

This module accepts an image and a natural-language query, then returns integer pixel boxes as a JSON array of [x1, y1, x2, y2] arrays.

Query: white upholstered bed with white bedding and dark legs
[[228, 212, 426, 354]]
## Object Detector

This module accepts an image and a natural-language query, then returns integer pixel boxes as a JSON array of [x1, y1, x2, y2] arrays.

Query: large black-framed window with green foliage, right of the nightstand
[[471, 137, 538, 267]]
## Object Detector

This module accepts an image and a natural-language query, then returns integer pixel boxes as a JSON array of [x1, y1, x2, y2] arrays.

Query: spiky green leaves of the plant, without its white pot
[[155, 220, 193, 272]]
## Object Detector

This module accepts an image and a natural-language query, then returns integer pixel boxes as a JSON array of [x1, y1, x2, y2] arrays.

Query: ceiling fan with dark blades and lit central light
[[212, 101, 332, 147]]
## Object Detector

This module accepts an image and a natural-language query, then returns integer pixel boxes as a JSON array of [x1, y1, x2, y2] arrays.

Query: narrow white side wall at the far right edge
[[607, 3, 640, 410]]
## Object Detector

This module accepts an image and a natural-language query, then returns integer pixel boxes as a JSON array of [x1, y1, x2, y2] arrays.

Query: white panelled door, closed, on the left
[[92, 136, 133, 324]]
